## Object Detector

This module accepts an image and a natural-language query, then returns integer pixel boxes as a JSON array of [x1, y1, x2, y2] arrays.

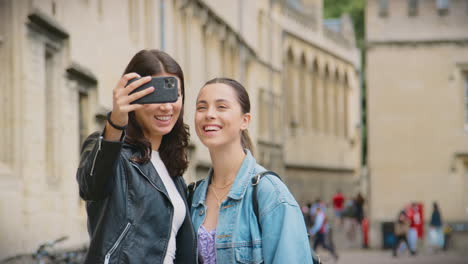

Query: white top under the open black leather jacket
[[151, 150, 186, 264]]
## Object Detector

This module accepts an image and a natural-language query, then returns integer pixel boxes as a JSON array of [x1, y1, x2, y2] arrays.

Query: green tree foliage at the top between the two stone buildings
[[323, 0, 365, 49]]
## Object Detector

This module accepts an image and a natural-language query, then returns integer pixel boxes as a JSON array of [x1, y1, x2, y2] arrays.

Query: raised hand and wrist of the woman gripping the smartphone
[[104, 72, 154, 141]]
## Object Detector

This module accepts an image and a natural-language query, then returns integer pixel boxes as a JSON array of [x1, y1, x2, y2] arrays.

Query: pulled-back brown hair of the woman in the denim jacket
[[204, 77, 254, 154]]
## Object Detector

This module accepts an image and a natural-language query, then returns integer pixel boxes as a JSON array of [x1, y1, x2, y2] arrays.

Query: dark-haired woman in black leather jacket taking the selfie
[[77, 50, 196, 264]]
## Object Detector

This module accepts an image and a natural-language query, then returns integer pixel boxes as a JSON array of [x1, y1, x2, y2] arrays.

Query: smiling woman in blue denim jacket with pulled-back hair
[[189, 78, 312, 264]]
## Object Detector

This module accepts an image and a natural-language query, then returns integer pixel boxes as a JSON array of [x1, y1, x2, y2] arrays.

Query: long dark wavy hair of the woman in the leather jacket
[[124, 50, 190, 177]]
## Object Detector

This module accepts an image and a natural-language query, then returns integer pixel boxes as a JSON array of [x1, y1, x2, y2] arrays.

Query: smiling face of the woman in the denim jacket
[[195, 83, 250, 149]]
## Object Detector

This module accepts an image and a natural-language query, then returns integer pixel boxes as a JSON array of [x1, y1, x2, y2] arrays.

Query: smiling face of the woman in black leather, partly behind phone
[[135, 73, 182, 139]]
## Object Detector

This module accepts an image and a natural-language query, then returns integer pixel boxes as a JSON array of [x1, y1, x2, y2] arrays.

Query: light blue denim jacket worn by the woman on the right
[[191, 150, 312, 264]]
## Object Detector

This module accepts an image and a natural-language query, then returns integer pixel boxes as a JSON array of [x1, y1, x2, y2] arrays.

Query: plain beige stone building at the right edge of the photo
[[366, 0, 468, 248]]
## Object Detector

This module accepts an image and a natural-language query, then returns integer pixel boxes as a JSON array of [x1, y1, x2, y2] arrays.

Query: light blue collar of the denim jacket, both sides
[[192, 149, 257, 206]]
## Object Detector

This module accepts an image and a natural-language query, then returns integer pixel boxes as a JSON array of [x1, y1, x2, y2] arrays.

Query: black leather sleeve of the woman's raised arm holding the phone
[[76, 132, 123, 201]]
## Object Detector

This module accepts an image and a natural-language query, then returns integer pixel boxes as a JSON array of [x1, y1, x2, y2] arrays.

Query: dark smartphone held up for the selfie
[[126, 76, 179, 104]]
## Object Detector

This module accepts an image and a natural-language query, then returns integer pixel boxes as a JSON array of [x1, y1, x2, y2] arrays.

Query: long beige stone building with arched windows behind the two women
[[0, 0, 361, 258]]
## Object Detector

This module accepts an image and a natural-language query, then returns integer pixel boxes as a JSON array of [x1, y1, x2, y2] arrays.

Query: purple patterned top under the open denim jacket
[[198, 225, 216, 264]]
